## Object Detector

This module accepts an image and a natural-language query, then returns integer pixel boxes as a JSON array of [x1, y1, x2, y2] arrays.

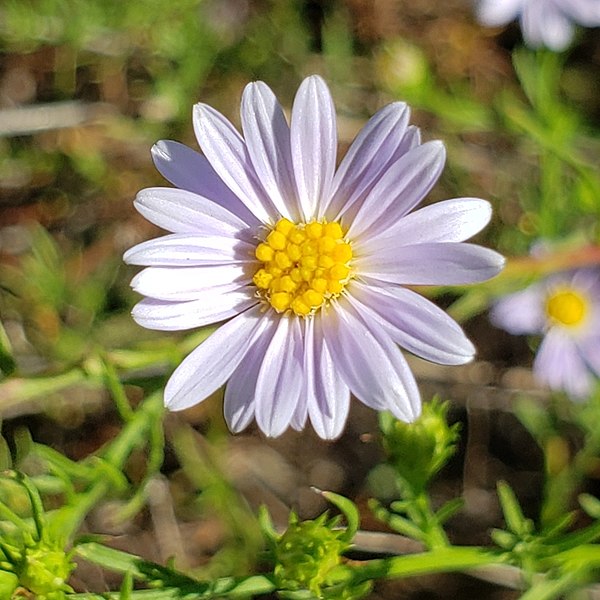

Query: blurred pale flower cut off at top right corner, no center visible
[[478, 0, 600, 51]]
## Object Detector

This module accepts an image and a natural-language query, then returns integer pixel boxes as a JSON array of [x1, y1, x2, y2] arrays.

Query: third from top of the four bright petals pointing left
[[131, 264, 254, 302]]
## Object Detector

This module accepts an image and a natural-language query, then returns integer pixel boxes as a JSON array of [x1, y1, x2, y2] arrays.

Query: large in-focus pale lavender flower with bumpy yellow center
[[125, 76, 503, 438]]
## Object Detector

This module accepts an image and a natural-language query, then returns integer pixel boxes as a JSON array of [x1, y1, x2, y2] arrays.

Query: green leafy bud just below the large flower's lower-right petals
[[380, 398, 458, 493]]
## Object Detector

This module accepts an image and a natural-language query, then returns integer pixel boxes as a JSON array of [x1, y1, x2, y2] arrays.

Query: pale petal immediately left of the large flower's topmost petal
[[241, 81, 300, 221]]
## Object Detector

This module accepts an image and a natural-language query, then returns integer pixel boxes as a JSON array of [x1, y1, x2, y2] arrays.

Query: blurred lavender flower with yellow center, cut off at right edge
[[491, 268, 600, 399]]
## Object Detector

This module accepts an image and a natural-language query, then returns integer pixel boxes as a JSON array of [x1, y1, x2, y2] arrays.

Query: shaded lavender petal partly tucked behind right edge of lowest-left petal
[[223, 320, 277, 433]]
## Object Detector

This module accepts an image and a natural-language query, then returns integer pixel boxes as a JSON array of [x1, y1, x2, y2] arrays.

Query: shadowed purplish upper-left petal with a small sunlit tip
[[151, 140, 259, 225]]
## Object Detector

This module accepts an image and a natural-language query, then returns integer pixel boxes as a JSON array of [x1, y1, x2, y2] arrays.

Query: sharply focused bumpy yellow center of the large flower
[[253, 219, 352, 316]]
